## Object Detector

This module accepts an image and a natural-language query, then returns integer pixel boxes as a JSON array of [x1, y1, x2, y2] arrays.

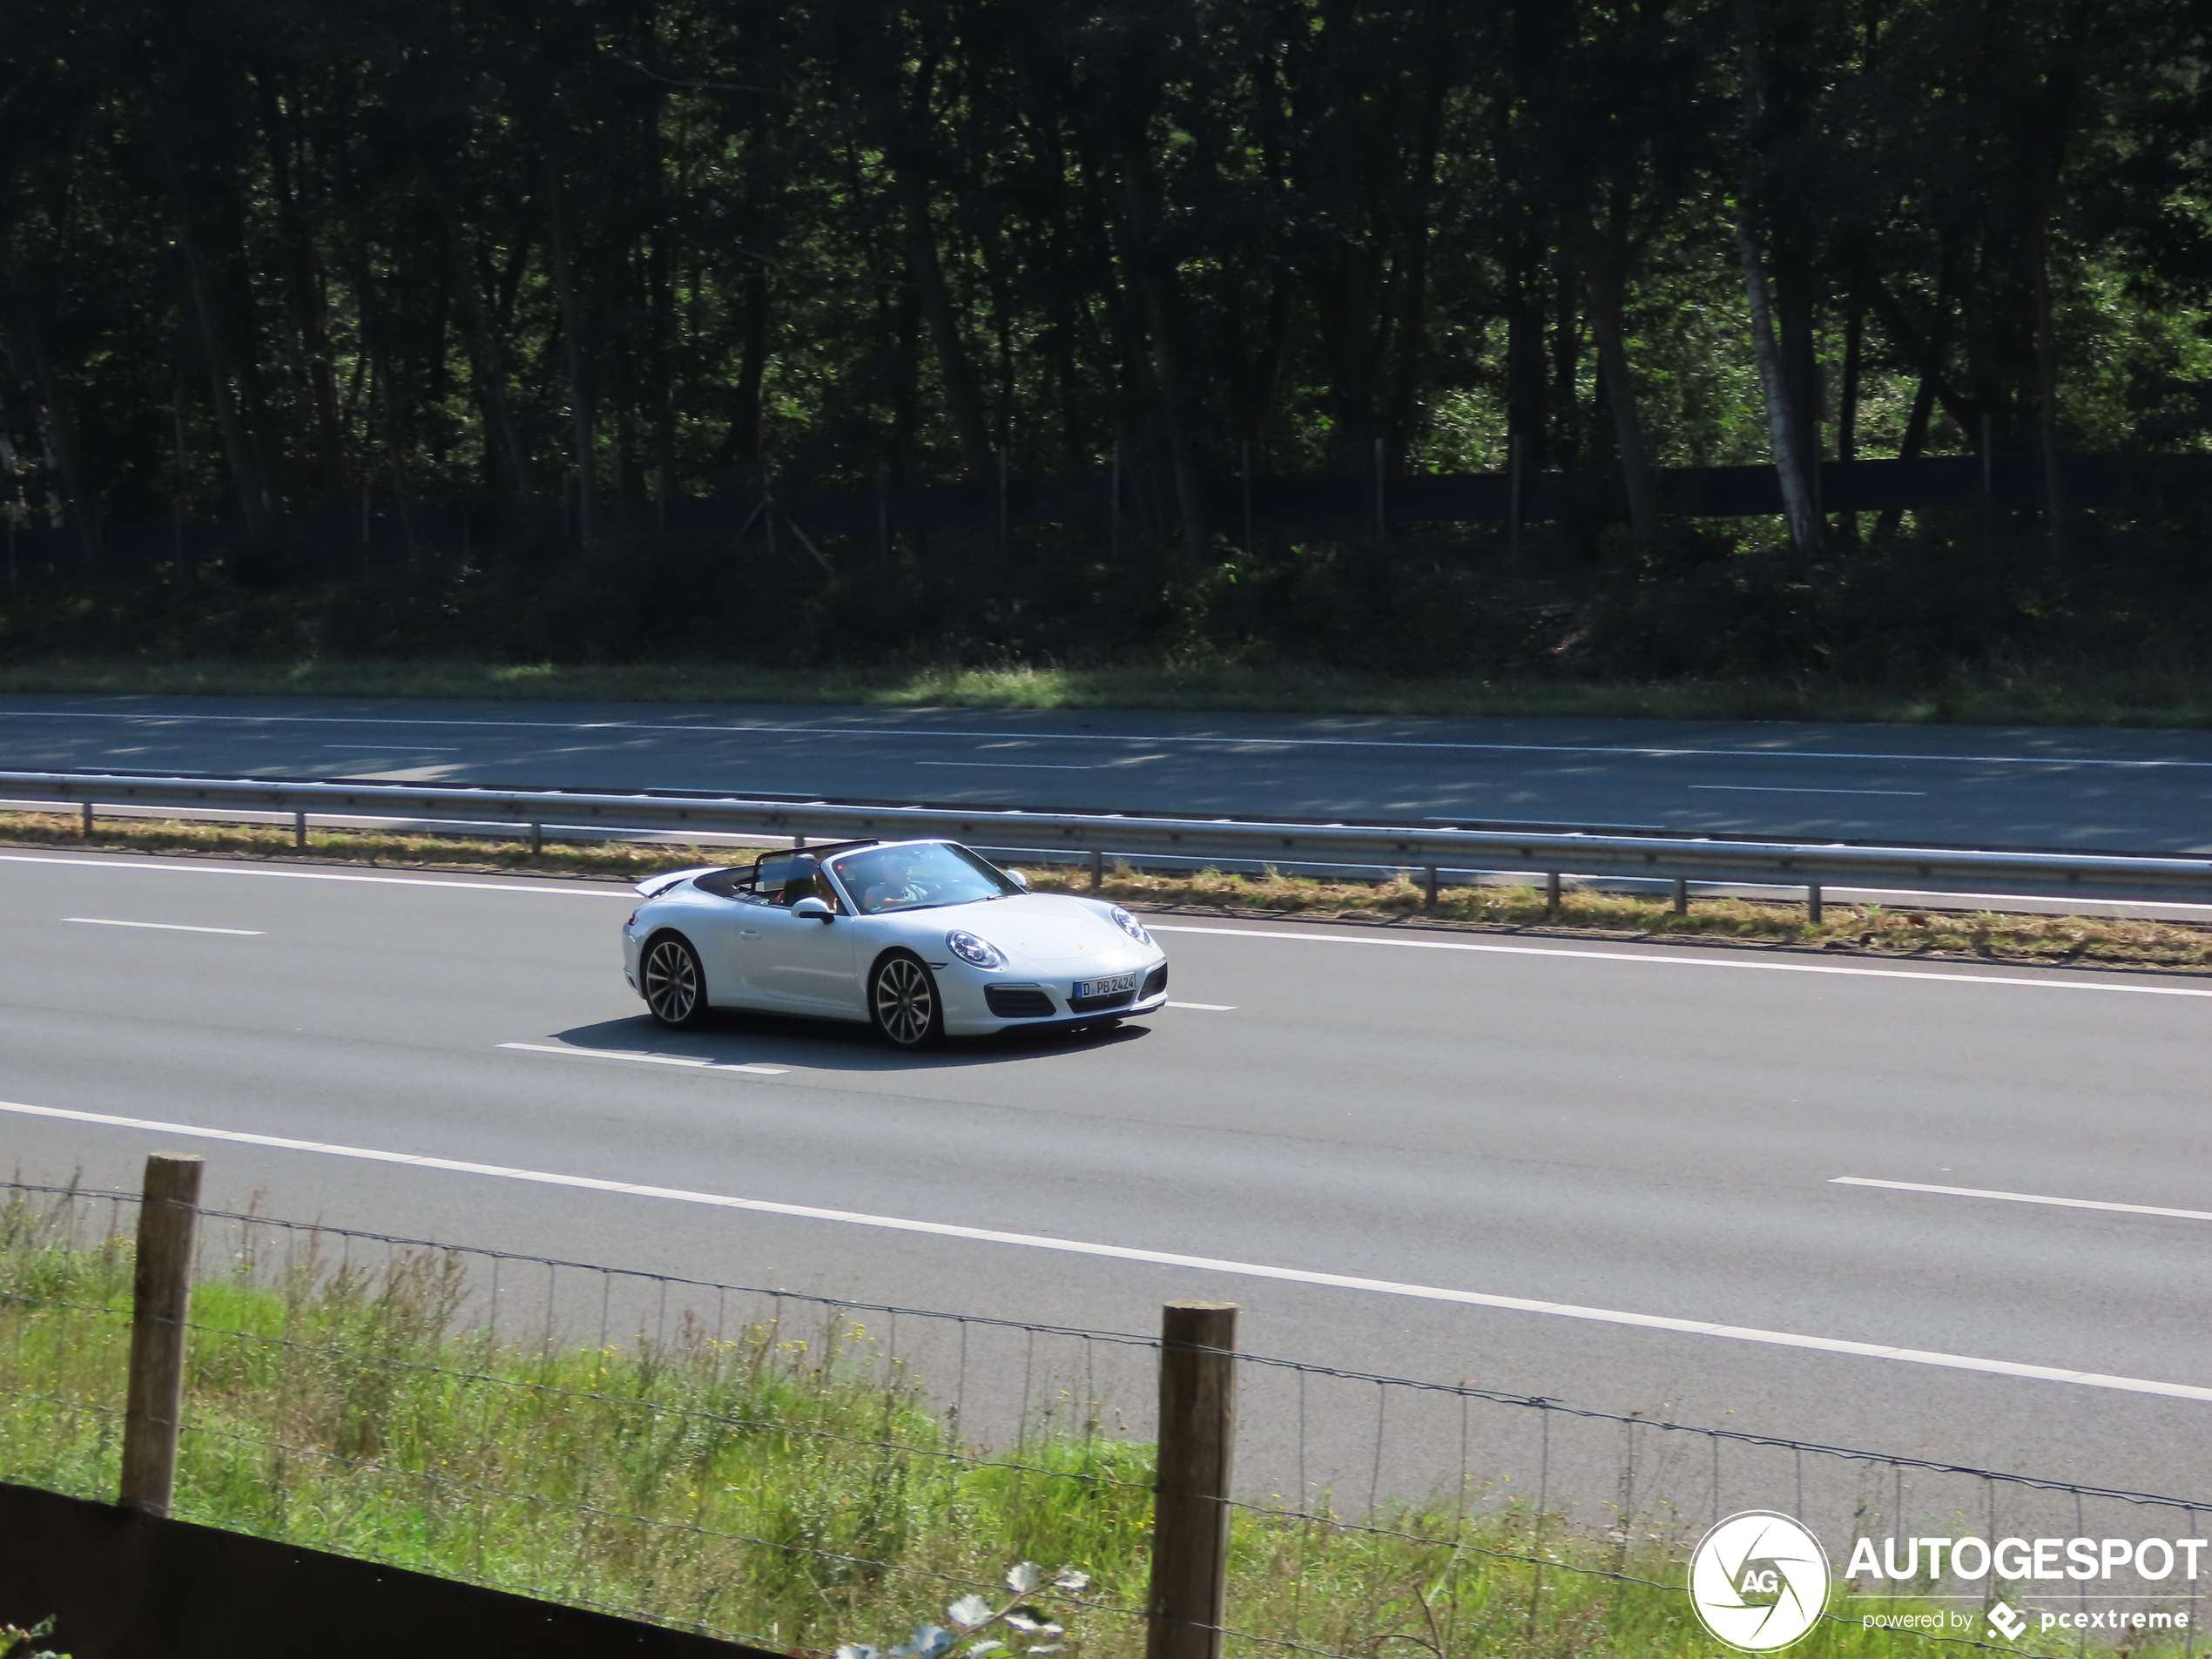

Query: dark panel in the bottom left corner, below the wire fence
[[0, 1482, 777, 1659]]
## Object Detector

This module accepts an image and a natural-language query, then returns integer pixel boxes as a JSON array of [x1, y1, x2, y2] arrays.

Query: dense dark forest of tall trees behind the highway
[[0, 0, 2212, 672]]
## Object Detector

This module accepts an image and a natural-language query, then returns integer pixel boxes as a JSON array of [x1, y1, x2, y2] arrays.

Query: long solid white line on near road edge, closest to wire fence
[[0, 1102, 2212, 1400]]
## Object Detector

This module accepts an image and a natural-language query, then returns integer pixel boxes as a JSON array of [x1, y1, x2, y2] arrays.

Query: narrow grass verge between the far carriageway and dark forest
[[12, 657, 2212, 728]]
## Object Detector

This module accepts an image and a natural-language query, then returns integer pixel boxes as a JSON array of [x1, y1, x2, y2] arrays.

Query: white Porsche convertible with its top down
[[622, 840, 1168, 1049]]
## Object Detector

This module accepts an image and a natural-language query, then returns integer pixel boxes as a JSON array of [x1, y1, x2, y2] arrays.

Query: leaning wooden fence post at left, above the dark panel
[[119, 1152, 204, 1515]]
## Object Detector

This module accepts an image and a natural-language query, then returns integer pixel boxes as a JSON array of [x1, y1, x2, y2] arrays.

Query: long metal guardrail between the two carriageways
[[0, 772, 2212, 905]]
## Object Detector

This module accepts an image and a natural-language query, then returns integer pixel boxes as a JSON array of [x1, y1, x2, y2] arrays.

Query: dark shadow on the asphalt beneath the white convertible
[[546, 1008, 1152, 1073]]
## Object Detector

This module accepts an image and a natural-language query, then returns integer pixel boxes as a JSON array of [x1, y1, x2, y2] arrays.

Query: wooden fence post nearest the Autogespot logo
[[1143, 1303, 1237, 1659]]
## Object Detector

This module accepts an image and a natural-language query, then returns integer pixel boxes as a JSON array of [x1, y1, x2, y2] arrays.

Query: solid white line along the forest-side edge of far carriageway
[[0, 708, 2212, 772]]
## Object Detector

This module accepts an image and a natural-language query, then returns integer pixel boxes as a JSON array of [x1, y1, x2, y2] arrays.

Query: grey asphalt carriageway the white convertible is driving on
[[0, 853, 2212, 1557]]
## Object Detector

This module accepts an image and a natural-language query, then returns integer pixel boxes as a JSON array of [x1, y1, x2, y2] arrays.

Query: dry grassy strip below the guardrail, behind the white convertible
[[0, 812, 2212, 974]]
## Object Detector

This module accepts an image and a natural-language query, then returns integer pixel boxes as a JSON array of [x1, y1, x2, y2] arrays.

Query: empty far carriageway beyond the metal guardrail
[[12, 695, 2212, 852]]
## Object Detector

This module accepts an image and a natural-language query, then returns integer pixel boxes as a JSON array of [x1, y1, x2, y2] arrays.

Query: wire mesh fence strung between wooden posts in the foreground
[[0, 1184, 2212, 1659]]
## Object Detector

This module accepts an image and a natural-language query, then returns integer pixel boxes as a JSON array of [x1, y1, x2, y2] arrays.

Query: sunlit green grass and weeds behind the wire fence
[[0, 1197, 2159, 1659]]
